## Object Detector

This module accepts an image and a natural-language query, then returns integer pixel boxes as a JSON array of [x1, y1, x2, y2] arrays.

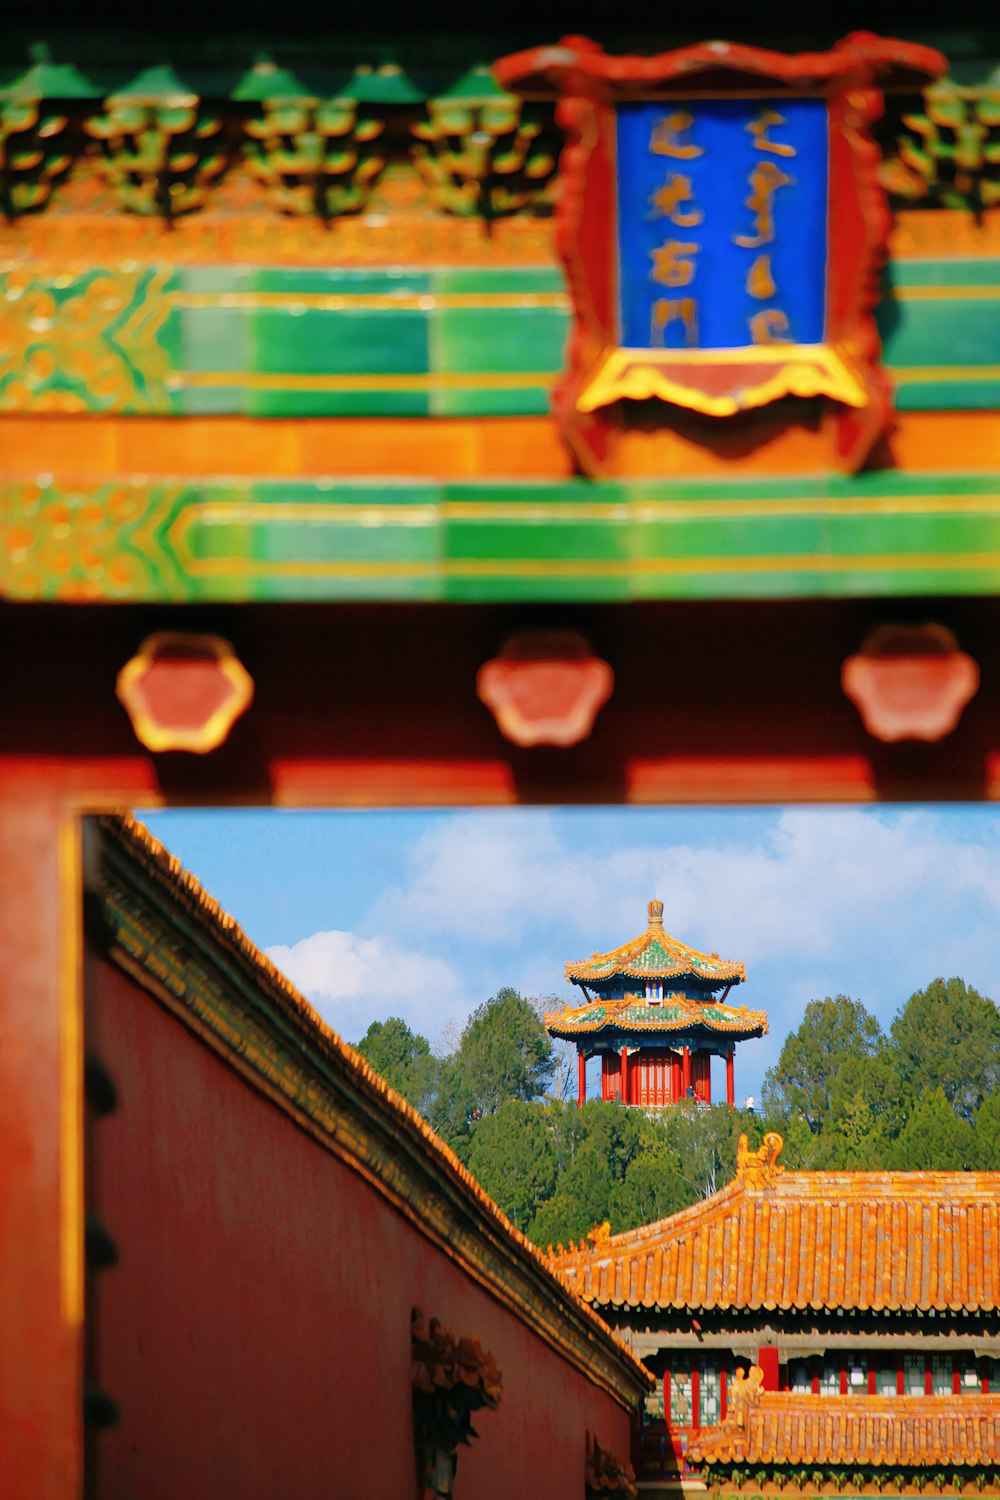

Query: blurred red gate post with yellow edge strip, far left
[[0, 798, 82, 1500]]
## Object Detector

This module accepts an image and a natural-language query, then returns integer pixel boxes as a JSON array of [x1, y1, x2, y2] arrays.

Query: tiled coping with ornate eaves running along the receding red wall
[[85, 816, 652, 1410]]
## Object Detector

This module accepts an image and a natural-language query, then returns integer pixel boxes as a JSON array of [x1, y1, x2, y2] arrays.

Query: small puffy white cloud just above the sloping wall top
[[267, 932, 475, 1041]]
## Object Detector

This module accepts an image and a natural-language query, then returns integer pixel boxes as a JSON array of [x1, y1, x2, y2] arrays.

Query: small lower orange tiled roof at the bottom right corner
[[687, 1391, 1000, 1469]]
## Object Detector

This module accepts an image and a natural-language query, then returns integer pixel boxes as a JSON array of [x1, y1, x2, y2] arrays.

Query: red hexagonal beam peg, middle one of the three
[[475, 630, 615, 746]]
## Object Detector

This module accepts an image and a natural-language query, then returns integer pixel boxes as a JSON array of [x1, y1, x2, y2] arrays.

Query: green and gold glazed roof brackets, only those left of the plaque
[[0, 57, 558, 224]]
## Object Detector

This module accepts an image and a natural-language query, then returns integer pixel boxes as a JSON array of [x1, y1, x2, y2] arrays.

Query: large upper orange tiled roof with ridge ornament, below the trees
[[552, 1134, 1000, 1311]]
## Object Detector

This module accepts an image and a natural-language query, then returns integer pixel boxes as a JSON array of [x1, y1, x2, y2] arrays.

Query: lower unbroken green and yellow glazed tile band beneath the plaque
[[0, 471, 1000, 602]]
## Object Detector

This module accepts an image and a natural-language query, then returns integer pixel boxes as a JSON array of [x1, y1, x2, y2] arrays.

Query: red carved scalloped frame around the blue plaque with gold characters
[[495, 32, 946, 474]]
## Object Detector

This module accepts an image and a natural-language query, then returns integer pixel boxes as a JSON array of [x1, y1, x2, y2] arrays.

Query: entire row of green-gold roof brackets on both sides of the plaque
[[0, 41, 1000, 224]]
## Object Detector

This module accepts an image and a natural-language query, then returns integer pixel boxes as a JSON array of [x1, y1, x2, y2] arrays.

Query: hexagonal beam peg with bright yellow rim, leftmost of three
[[117, 630, 253, 755]]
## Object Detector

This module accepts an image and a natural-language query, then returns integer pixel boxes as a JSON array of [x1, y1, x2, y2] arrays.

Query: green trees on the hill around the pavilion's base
[[358, 978, 1000, 1248]]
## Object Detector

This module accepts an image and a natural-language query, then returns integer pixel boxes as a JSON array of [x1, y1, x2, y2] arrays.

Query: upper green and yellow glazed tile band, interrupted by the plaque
[[0, 260, 1000, 417]]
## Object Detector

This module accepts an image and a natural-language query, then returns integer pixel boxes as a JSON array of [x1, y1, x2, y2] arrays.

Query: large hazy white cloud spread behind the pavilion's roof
[[359, 809, 1000, 1082]]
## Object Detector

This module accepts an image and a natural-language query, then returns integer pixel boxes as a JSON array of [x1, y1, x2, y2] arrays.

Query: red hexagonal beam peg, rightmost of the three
[[841, 624, 979, 743]]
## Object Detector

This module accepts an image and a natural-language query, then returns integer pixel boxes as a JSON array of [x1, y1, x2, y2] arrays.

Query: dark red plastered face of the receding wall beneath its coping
[[87, 959, 630, 1500]]
